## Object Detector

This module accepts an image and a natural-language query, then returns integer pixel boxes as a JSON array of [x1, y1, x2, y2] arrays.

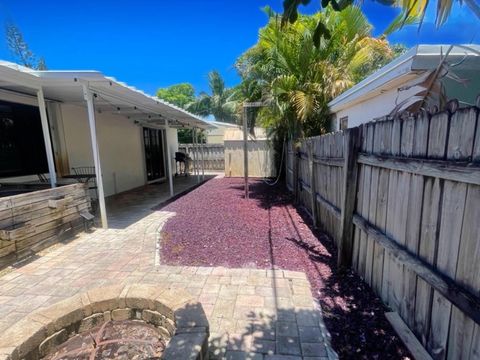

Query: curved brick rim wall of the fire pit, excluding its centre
[[0, 284, 209, 360]]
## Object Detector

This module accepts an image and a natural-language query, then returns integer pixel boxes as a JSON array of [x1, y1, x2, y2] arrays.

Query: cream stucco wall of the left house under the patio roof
[[0, 93, 178, 196]]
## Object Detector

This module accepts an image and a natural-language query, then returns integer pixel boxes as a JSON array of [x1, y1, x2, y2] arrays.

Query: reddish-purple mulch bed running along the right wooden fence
[[161, 178, 411, 359]]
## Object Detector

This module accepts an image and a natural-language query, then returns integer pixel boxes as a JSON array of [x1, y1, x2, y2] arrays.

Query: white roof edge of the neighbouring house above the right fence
[[328, 45, 480, 112]]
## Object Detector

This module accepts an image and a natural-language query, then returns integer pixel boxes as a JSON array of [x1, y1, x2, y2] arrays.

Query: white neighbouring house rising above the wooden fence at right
[[328, 45, 480, 130]]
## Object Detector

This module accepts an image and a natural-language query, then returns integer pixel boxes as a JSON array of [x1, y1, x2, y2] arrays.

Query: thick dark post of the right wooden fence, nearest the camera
[[337, 127, 361, 268]]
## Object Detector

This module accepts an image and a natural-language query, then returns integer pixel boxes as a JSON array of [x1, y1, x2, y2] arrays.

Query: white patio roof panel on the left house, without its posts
[[0, 61, 209, 129]]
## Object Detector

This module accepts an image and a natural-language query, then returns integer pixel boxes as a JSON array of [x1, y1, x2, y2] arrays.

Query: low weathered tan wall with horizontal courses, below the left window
[[0, 184, 90, 269]]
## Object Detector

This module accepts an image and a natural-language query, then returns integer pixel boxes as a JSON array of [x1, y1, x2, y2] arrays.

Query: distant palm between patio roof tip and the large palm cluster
[[187, 70, 237, 123]]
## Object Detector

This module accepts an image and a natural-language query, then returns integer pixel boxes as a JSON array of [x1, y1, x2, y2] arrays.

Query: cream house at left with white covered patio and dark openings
[[0, 61, 209, 227]]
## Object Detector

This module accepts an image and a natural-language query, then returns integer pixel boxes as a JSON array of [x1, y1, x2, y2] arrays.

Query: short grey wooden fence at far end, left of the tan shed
[[178, 144, 225, 171]]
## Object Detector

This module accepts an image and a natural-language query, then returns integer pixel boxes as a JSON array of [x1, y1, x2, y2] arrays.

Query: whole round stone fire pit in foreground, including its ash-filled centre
[[0, 285, 209, 360]]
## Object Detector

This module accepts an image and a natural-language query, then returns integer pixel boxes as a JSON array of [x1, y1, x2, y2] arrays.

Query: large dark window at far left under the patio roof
[[0, 101, 48, 178]]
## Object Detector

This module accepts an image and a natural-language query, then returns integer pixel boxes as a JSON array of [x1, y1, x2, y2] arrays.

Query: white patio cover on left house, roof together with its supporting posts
[[0, 61, 212, 228]]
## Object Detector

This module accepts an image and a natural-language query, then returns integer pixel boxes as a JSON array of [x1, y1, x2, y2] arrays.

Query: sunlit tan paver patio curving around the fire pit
[[0, 176, 335, 360]]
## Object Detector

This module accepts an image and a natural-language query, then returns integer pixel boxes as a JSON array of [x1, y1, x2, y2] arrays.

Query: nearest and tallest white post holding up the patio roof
[[83, 84, 108, 229]]
